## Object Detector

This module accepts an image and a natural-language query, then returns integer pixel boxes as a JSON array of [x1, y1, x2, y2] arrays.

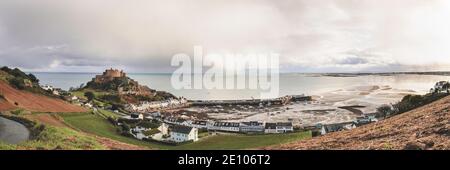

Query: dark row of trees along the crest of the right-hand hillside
[[377, 93, 448, 118]]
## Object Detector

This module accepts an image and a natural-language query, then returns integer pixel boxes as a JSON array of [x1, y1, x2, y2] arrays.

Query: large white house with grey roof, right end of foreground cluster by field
[[170, 125, 198, 143]]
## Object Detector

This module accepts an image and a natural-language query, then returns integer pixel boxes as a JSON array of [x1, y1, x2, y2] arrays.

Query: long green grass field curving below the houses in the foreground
[[61, 113, 311, 150]]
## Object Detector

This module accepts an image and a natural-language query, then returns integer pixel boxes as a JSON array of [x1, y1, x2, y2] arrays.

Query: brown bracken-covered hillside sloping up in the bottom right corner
[[265, 96, 450, 150]]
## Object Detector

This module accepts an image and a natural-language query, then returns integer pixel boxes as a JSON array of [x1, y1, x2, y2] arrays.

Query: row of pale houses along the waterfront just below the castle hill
[[125, 98, 188, 113]]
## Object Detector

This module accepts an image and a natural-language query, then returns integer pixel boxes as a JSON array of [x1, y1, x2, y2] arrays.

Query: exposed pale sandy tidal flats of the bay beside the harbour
[[173, 85, 418, 126]]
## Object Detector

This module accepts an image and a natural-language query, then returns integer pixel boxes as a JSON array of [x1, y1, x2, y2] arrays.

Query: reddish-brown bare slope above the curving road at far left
[[0, 81, 86, 112]]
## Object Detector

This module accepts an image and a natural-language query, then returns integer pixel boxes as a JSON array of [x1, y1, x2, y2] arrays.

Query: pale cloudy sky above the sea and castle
[[0, 0, 450, 72]]
